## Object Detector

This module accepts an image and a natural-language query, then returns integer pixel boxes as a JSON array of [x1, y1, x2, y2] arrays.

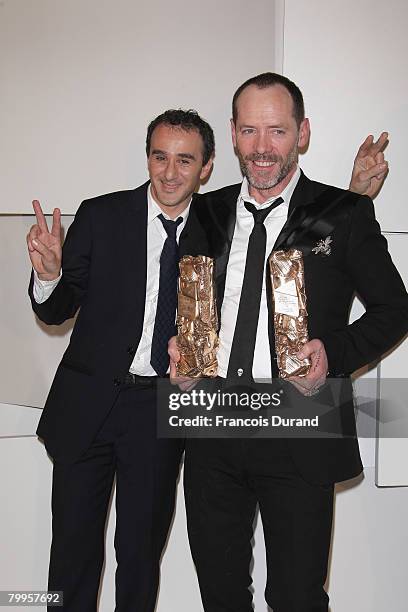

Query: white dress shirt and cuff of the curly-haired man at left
[[33, 186, 191, 376]]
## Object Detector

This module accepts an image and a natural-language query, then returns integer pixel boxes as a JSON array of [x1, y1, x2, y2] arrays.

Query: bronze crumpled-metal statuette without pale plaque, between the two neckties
[[177, 255, 218, 378]]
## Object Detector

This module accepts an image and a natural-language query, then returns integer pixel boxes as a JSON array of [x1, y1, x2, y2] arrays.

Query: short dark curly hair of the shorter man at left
[[146, 108, 215, 166]]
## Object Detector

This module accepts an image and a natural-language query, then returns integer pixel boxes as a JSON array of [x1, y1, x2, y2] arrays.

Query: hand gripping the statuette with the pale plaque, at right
[[288, 339, 328, 396]]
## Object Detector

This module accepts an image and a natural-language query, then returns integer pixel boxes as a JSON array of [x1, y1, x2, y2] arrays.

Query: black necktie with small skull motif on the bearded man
[[227, 198, 283, 380]]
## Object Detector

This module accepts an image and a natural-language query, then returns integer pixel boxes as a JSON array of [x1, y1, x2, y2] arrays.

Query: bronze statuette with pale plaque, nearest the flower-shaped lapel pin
[[269, 249, 310, 378]]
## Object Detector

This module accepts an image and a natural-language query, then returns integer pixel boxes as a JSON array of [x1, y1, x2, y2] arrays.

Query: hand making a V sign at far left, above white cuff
[[27, 200, 62, 280]]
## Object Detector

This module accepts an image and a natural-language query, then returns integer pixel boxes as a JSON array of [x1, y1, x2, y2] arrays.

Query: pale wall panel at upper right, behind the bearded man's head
[[284, 0, 408, 231]]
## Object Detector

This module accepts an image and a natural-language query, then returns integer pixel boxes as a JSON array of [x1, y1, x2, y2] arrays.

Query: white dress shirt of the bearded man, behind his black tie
[[218, 167, 300, 380]]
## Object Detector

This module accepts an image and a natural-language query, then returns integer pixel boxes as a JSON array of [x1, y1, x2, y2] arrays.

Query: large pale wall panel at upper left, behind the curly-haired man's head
[[0, 0, 283, 213]]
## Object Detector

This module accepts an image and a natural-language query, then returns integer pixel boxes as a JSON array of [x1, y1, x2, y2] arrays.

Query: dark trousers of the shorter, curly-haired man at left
[[48, 387, 184, 612]]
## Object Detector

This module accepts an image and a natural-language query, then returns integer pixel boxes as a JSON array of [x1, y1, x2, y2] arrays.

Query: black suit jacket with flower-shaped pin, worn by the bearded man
[[182, 174, 408, 483]]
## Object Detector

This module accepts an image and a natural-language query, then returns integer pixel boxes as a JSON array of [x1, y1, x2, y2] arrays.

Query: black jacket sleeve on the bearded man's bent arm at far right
[[321, 196, 408, 376]]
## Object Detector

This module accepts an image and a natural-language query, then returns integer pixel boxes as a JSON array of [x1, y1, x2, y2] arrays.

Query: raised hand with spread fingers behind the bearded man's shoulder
[[349, 132, 388, 198]]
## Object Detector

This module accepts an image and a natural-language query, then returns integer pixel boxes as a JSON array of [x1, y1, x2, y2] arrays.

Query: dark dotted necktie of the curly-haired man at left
[[150, 215, 183, 376]]
